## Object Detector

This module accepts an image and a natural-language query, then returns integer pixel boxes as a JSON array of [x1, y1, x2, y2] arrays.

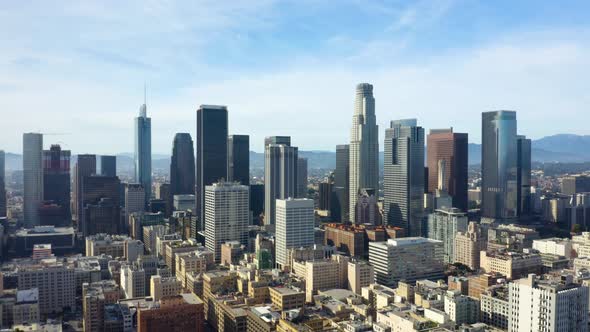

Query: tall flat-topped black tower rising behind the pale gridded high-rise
[[195, 105, 227, 230]]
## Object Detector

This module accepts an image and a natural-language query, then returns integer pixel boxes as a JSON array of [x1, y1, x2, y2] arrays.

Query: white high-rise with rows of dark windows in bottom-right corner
[[508, 274, 588, 332]]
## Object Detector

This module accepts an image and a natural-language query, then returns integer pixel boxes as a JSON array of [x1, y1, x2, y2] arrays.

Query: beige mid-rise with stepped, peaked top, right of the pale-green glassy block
[[453, 222, 487, 270]]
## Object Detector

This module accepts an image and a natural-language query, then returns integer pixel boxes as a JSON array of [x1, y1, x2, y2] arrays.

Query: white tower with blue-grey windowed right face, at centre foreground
[[275, 198, 314, 269]]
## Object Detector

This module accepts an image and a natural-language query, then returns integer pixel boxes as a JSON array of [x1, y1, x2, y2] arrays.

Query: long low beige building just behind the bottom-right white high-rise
[[479, 251, 543, 279]]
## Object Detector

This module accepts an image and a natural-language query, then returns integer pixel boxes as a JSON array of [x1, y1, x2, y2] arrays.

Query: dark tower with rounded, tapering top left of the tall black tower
[[170, 133, 195, 200]]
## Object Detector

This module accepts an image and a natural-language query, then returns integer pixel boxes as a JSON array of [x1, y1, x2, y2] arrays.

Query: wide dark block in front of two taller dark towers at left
[[78, 175, 121, 236]]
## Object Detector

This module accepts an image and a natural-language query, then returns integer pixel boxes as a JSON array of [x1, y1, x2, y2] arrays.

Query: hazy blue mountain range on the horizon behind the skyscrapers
[[6, 134, 590, 170]]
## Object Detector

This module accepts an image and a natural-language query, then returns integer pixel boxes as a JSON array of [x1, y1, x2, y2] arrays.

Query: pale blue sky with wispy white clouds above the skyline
[[0, 0, 590, 154]]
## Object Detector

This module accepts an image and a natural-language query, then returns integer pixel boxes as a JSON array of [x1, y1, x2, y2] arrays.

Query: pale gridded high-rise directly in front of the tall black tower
[[205, 182, 250, 263]]
